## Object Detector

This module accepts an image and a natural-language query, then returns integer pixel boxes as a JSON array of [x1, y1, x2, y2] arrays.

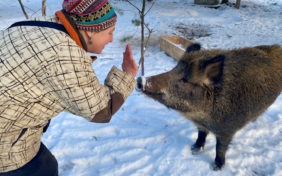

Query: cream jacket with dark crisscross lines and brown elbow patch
[[0, 18, 136, 173]]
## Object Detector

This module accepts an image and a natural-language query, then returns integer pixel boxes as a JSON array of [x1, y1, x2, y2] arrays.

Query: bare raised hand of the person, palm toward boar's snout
[[121, 45, 138, 77]]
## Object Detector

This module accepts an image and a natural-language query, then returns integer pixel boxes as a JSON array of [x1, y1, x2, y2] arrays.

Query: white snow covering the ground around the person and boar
[[0, 0, 282, 176]]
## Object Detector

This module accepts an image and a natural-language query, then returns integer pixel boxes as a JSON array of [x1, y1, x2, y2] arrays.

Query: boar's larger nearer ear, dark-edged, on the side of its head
[[205, 55, 225, 85]]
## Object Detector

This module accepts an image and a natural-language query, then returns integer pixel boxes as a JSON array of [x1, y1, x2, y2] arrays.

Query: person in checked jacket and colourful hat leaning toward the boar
[[0, 0, 138, 176]]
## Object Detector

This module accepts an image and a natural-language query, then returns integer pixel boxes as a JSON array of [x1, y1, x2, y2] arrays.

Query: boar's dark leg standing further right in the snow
[[213, 136, 232, 170]]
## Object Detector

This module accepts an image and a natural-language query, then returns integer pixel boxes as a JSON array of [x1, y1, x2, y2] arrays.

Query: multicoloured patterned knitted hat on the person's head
[[63, 0, 117, 32]]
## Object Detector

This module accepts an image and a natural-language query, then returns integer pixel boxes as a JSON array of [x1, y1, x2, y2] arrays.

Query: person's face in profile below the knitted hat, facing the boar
[[86, 26, 115, 54]]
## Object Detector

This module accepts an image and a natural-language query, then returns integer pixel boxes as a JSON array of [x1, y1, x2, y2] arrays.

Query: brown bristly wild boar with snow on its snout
[[137, 44, 282, 170]]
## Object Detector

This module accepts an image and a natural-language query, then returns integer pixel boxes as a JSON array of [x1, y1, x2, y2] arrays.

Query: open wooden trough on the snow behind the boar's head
[[160, 36, 194, 61]]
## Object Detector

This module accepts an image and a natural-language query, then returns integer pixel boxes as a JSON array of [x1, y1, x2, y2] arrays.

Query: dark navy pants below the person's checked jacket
[[0, 143, 58, 176]]
